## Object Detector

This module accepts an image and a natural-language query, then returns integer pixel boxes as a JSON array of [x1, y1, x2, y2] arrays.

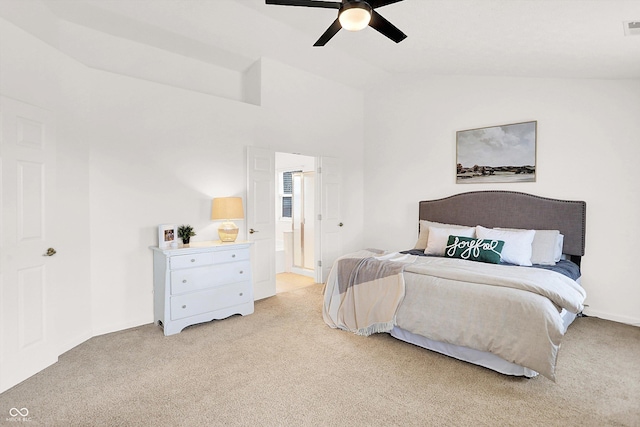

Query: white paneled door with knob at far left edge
[[0, 96, 58, 392]]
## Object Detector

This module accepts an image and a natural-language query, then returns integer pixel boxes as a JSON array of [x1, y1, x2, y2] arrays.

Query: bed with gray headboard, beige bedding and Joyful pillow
[[323, 191, 586, 381]]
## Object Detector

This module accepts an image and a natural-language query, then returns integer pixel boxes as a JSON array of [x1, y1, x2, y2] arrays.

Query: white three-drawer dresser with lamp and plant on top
[[151, 241, 253, 335]]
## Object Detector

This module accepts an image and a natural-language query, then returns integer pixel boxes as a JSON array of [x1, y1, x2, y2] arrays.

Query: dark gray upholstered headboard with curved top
[[420, 191, 587, 265]]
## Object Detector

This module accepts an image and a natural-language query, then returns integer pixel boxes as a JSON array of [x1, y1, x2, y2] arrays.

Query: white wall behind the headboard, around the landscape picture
[[364, 77, 640, 324]]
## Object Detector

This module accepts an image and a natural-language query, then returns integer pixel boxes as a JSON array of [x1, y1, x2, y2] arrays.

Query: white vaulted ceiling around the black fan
[[5, 0, 640, 87]]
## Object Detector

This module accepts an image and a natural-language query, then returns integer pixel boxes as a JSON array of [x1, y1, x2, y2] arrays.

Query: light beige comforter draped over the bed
[[323, 251, 586, 380]]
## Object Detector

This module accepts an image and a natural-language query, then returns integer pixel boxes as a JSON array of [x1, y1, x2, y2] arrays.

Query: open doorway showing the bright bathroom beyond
[[275, 153, 316, 293]]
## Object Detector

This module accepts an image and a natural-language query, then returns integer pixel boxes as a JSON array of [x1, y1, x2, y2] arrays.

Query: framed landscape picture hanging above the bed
[[456, 121, 538, 184]]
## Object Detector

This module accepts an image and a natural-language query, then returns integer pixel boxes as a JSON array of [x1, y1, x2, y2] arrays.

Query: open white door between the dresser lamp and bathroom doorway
[[247, 147, 276, 300]]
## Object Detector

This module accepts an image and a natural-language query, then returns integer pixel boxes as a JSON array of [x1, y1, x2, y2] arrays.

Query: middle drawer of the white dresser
[[171, 260, 251, 295]]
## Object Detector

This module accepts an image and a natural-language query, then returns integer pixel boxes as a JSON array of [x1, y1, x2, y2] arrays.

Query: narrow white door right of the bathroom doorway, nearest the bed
[[316, 157, 344, 283]]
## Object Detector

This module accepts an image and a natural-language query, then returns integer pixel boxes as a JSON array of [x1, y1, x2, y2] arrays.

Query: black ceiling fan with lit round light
[[266, 0, 407, 46]]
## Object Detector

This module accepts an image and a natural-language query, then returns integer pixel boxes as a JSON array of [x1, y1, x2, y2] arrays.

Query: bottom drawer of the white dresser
[[170, 282, 253, 320]]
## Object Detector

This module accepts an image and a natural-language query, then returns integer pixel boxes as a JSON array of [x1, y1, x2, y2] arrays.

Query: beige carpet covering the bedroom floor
[[0, 285, 640, 426]]
